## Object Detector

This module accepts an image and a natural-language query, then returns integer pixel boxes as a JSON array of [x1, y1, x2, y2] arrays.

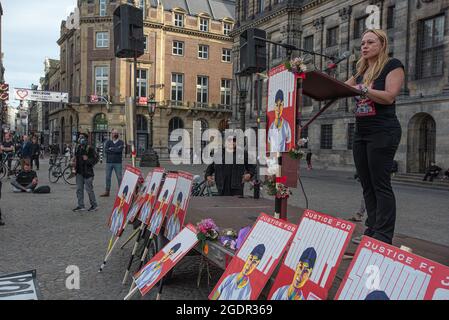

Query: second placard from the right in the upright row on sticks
[[148, 173, 178, 236]]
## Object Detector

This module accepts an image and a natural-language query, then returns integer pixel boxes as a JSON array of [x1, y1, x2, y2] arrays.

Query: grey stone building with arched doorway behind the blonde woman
[[232, 0, 449, 173]]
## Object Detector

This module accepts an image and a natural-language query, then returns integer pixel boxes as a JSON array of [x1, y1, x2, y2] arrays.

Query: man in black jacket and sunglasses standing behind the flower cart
[[206, 137, 256, 196]]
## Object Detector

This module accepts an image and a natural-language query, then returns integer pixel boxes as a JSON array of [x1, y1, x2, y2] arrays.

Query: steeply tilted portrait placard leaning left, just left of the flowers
[[134, 224, 198, 296]]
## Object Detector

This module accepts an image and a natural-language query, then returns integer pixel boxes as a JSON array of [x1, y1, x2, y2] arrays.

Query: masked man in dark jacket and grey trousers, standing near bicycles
[[73, 134, 98, 212]]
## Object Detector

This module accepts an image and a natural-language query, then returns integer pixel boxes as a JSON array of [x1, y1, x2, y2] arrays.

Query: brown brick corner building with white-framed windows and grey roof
[[49, 0, 235, 157]]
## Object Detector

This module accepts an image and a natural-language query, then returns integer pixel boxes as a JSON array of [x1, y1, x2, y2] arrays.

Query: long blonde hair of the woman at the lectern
[[355, 29, 390, 85]]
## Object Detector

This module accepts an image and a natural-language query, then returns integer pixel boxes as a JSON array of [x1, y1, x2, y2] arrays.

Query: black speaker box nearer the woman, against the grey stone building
[[240, 28, 267, 74]]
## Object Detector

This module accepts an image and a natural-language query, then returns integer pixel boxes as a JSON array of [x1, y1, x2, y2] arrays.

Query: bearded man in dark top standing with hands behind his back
[[101, 129, 125, 197]]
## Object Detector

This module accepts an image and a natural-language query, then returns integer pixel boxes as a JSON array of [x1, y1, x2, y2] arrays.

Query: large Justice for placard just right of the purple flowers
[[209, 214, 297, 300]]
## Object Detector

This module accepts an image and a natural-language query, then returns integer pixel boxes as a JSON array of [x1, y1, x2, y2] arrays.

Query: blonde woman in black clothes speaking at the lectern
[[346, 29, 405, 244]]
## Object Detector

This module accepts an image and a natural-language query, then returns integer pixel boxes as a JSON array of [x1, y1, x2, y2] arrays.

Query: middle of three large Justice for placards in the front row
[[268, 210, 355, 300]]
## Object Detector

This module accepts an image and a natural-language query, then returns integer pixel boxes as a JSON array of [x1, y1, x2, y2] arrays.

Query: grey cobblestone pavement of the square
[[0, 161, 449, 300]]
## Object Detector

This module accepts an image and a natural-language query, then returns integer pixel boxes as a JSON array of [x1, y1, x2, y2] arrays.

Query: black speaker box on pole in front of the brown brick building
[[113, 4, 145, 58]]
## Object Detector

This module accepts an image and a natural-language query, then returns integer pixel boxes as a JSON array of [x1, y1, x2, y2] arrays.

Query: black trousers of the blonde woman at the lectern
[[353, 128, 402, 244]]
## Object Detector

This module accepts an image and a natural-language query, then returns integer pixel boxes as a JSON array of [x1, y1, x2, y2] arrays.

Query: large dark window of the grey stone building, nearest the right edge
[[416, 15, 444, 79]]
